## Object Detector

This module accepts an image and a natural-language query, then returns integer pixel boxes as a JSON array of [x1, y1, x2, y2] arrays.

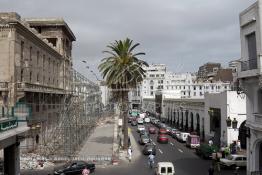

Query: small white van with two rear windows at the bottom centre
[[155, 162, 175, 175]]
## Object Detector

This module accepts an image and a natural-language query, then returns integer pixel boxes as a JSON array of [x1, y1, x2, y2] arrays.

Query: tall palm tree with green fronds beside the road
[[98, 38, 148, 149]]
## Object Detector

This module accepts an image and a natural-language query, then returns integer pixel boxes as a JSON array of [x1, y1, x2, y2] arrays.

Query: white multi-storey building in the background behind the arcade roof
[[141, 64, 231, 99]]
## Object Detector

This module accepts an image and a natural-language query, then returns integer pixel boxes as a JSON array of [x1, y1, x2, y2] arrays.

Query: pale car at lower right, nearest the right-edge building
[[219, 154, 247, 168]]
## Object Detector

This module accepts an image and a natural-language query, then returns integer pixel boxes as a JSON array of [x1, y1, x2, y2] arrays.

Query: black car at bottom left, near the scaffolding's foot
[[54, 161, 95, 175]]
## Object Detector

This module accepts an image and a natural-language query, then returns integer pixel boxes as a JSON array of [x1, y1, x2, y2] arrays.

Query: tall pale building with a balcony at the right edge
[[237, 0, 262, 174]]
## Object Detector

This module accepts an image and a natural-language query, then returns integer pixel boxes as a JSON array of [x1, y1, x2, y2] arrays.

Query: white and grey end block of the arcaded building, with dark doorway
[[204, 91, 246, 148]]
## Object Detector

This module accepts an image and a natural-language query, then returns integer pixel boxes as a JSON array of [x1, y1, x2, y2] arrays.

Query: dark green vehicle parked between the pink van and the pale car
[[196, 143, 219, 159]]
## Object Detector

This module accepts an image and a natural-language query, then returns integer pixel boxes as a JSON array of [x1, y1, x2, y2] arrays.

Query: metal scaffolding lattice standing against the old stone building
[[40, 70, 102, 157]]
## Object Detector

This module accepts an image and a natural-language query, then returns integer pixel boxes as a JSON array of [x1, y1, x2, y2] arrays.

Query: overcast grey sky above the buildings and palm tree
[[0, 0, 255, 79]]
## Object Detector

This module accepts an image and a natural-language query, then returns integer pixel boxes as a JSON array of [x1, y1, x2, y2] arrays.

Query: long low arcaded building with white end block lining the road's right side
[[143, 91, 246, 148]]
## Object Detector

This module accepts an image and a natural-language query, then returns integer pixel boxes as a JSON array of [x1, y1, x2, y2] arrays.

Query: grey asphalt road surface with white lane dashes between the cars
[[95, 122, 246, 175]]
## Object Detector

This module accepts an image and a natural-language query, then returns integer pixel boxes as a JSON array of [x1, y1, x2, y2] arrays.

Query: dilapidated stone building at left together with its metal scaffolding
[[0, 12, 101, 174]]
